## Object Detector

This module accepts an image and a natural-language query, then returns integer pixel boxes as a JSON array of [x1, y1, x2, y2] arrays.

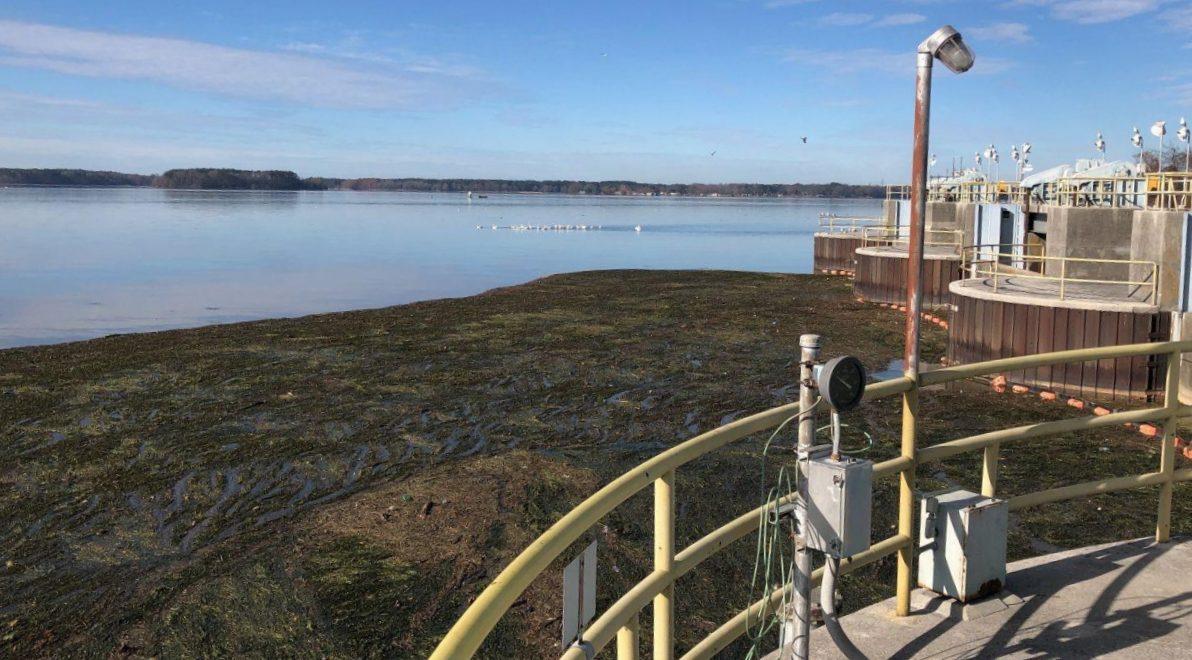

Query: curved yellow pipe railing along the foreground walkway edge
[[432, 341, 1192, 660]]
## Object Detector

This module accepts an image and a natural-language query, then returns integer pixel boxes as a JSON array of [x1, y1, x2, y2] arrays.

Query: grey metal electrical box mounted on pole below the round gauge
[[806, 456, 874, 558]]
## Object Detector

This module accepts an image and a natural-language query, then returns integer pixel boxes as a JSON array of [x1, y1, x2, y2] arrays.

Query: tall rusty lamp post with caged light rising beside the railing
[[895, 25, 974, 616]]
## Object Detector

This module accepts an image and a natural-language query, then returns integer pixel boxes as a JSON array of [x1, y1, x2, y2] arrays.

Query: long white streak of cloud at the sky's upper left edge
[[0, 20, 495, 110]]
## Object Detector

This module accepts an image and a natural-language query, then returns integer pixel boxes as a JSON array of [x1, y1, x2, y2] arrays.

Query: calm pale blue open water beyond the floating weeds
[[0, 188, 880, 347]]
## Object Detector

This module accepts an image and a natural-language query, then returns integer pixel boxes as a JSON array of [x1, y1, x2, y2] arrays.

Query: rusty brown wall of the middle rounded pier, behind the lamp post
[[852, 253, 961, 310]]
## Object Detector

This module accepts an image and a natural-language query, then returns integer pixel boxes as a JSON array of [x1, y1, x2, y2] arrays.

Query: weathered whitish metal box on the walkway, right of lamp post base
[[919, 490, 1010, 603]]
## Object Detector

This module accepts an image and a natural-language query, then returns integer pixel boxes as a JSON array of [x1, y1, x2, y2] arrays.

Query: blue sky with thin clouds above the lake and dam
[[0, 0, 1192, 182]]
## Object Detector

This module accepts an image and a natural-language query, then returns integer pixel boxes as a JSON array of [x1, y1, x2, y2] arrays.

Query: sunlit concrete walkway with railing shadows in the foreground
[[781, 538, 1192, 660]]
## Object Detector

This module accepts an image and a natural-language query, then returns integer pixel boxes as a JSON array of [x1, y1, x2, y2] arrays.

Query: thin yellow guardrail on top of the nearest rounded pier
[[961, 243, 1159, 303]]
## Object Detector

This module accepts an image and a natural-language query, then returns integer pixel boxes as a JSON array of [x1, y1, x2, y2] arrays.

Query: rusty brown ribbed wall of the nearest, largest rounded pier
[[948, 291, 1171, 401]]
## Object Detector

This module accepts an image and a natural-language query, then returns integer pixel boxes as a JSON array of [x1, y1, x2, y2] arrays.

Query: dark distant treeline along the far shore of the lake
[[0, 168, 884, 198]]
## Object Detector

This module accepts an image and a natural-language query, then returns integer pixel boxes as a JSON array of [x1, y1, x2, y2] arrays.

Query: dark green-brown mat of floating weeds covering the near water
[[0, 272, 1192, 658]]
